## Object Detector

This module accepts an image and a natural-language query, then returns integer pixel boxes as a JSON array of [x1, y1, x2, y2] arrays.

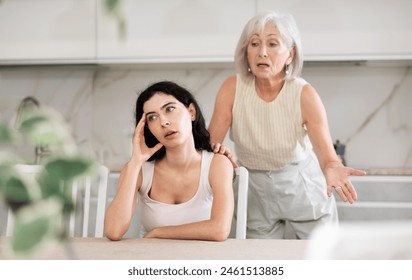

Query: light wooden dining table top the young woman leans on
[[0, 237, 308, 260]]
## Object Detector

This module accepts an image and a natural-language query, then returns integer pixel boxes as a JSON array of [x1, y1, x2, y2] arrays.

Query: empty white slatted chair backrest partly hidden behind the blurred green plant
[[6, 165, 109, 237]]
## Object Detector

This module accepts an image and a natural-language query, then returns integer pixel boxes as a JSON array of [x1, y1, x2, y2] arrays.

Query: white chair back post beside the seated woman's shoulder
[[235, 167, 249, 239]]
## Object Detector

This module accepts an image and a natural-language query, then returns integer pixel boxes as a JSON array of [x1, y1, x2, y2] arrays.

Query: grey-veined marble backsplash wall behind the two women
[[0, 63, 412, 171]]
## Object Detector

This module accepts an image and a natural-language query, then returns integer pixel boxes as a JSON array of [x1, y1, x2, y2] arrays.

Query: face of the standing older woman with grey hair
[[247, 23, 293, 79]]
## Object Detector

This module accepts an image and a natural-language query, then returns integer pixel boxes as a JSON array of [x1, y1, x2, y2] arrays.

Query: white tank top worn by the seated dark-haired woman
[[139, 151, 213, 237]]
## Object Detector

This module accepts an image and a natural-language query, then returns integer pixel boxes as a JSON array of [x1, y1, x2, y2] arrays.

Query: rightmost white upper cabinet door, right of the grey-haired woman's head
[[256, 0, 412, 60]]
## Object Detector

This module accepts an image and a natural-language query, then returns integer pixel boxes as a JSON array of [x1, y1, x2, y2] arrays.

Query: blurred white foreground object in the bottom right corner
[[305, 220, 412, 260]]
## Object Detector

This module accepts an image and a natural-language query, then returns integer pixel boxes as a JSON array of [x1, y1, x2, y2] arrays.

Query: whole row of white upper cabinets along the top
[[0, 0, 412, 65]]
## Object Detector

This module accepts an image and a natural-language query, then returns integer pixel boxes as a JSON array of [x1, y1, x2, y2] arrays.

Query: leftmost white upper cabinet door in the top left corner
[[0, 0, 96, 64]]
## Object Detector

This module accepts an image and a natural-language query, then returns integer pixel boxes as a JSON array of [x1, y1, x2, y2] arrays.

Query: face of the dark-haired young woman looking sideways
[[143, 93, 196, 147]]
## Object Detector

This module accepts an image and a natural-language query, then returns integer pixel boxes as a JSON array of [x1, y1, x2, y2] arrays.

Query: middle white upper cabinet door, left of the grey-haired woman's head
[[97, 0, 255, 62]]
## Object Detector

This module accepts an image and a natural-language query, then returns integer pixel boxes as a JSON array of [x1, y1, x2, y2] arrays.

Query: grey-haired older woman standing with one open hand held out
[[209, 12, 365, 239]]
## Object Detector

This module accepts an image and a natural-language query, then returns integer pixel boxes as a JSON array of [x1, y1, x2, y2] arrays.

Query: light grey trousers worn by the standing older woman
[[231, 154, 338, 239]]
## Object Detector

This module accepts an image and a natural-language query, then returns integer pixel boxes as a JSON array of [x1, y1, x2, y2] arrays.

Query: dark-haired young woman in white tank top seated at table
[[105, 81, 234, 241]]
